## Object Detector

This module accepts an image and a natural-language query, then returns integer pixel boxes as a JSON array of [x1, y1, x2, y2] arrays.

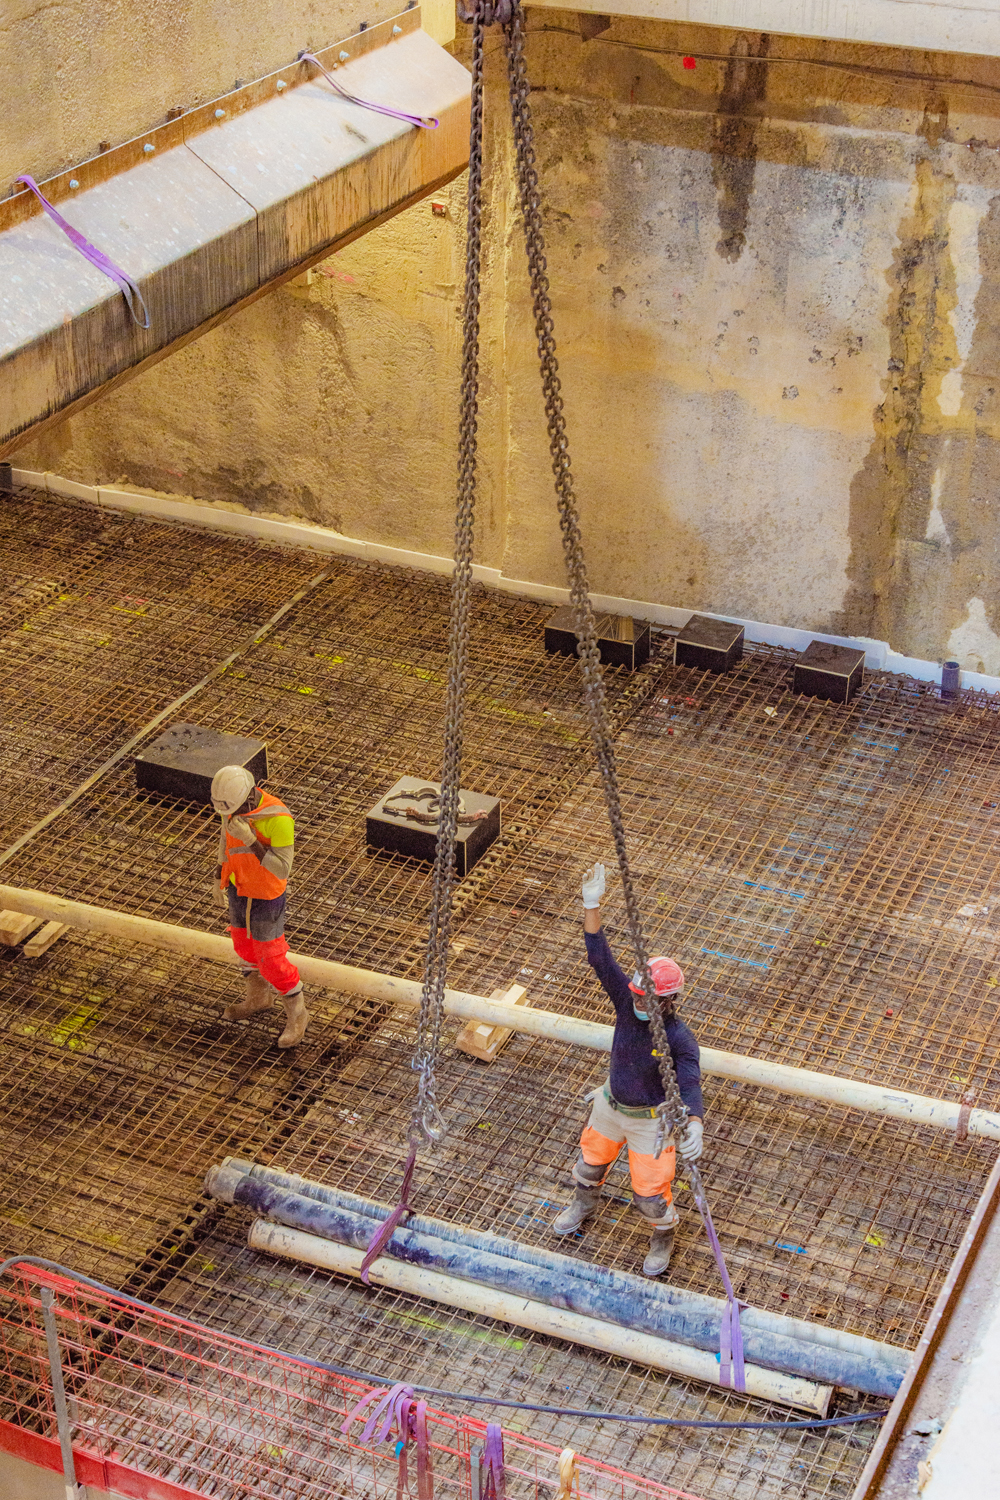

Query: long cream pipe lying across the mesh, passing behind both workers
[[0, 885, 1000, 1140]]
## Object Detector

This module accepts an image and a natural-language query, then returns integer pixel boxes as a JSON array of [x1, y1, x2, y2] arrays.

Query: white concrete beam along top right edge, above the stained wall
[[531, 0, 1000, 57]]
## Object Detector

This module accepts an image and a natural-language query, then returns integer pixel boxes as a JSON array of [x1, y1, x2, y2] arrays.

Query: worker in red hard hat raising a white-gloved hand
[[552, 864, 705, 1277]]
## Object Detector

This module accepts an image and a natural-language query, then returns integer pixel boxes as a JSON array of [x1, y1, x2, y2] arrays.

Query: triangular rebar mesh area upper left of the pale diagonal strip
[[0, 497, 316, 845]]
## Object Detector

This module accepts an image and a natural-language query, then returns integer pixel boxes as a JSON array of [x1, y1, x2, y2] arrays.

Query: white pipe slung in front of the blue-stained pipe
[[247, 1220, 834, 1416]]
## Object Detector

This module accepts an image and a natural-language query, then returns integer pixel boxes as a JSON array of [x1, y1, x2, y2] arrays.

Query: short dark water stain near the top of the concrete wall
[[711, 35, 771, 261]]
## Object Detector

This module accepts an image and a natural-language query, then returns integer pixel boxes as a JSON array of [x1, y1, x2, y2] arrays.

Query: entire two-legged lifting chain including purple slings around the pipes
[[370, 0, 745, 1391]]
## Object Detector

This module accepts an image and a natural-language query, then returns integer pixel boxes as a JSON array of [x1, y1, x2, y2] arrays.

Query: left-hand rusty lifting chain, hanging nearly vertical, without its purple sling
[[409, 14, 484, 1149]]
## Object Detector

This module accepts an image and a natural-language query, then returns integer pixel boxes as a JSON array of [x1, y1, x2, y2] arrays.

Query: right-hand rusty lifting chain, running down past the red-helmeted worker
[[504, 0, 700, 1152]]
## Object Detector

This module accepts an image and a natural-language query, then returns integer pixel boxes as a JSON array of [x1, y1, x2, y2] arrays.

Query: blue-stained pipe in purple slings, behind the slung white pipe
[[205, 1167, 909, 1397]]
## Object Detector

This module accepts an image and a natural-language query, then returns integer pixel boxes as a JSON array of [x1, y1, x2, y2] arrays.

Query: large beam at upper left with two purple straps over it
[[0, 9, 471, 455]]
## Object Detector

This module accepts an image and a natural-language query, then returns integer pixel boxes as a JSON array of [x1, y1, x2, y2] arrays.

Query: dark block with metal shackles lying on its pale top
[[364, 776, 501, 876]]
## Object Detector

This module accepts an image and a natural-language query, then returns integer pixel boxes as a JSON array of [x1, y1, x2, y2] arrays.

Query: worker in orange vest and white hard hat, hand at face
[[211, 765, 309, 1047]]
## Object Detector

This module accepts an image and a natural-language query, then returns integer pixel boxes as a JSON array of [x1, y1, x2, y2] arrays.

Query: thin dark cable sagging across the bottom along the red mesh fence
[[0, 1256, 886, 1433]]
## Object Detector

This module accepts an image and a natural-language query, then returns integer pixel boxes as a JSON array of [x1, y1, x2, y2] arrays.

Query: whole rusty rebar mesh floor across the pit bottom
[[0, 492, 1000, 1500]]
